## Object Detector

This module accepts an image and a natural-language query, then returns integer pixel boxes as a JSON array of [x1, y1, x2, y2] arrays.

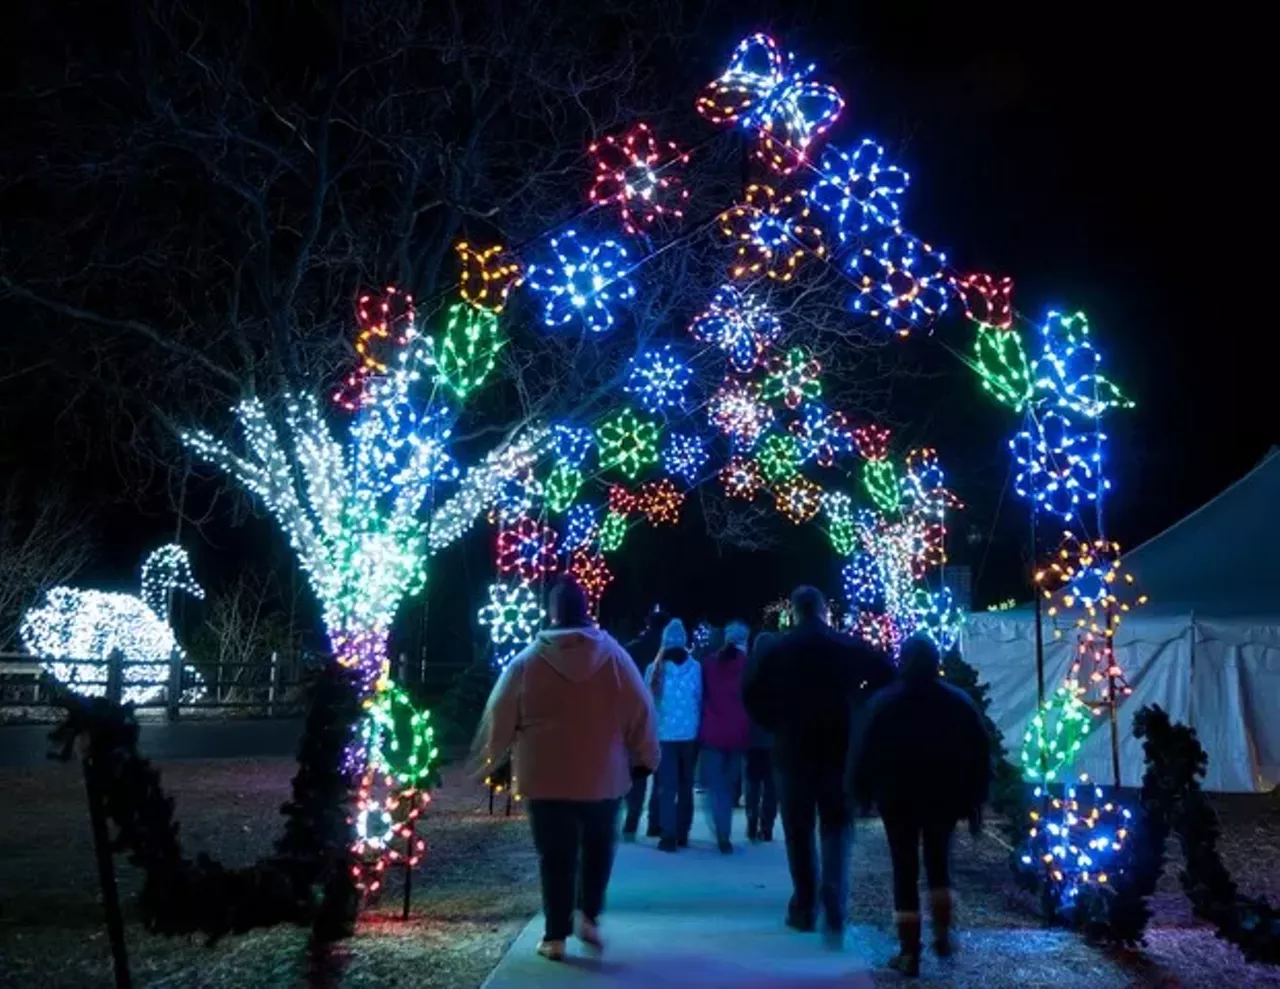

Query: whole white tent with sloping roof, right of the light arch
[[963, 449, 1280, 792]]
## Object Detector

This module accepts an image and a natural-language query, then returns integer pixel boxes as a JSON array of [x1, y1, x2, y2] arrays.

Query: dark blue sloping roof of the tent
[[1125, 448, 1280, 617]]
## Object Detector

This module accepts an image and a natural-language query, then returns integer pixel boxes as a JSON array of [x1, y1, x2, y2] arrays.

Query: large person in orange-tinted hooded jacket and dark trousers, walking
[[477, 578, 659, 961]]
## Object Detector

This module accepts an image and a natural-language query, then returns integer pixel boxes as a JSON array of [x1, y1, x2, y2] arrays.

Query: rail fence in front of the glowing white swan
[[0, 653, 467, 723]]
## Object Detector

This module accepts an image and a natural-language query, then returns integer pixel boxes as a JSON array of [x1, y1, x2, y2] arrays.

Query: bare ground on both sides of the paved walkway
[[0, 760, 1280, 989]]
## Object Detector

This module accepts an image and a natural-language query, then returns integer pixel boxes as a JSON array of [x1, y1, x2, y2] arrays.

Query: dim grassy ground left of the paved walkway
[[0, 760, 538, 989]]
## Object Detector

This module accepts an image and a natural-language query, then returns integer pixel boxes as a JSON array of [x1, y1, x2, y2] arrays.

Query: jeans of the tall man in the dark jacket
[[777, 766, 854, 930]]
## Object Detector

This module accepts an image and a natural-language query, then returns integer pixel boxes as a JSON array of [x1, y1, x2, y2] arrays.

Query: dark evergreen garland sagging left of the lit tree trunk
[[50, 663, 360, 942]]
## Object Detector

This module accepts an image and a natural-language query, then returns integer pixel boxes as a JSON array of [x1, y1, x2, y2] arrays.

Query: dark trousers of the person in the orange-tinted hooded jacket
[[529, 800, 618, 940]]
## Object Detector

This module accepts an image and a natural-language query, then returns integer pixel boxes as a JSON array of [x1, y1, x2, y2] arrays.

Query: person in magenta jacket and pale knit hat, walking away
[[699, 622, 751, 855]]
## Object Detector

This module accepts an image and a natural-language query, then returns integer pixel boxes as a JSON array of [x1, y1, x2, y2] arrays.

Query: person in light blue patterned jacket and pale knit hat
[[648, 618, 703, 852]]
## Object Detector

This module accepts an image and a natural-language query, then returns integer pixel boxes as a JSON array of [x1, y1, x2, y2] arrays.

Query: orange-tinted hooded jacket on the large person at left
[[481, 628, 658, 801]]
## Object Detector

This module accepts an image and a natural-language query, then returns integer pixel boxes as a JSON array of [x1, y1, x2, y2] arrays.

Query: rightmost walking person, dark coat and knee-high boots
[[849, 636, 991, 975]]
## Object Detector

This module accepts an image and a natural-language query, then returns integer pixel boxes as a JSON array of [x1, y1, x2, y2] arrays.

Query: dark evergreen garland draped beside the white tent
[[1024, 705, 1280, 965]]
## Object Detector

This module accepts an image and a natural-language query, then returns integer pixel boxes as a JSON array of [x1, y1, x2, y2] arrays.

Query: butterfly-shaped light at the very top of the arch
[[695, 33, 845, 174]]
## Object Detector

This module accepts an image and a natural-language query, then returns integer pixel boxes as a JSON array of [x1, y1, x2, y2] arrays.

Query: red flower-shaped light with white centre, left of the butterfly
[[588, 123, 689, 235]]
